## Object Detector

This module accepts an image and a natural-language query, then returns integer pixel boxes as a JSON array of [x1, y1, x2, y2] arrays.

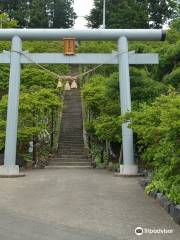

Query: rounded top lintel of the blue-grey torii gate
[[0, 28, 166, 41]]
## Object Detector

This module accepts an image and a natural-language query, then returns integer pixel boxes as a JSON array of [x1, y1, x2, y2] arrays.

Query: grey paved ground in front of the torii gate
[[0, 169, 180, 240]]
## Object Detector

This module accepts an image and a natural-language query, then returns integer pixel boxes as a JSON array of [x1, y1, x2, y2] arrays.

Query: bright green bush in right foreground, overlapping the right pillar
[[122, 92, 180, 203]]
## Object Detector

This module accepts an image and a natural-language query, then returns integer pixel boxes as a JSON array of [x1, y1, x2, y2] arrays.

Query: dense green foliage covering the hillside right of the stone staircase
[[80, 20, 180, 203]]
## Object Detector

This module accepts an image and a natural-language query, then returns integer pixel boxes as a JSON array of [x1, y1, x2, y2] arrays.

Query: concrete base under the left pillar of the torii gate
[[0, 165, 25, 178]]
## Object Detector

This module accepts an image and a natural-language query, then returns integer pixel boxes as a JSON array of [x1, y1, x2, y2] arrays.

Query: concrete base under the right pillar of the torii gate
[[114, 164, 144, 177]]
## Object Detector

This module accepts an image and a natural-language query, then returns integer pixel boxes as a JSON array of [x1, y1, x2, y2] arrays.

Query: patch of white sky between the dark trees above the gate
[[74, 0, 93, 29]]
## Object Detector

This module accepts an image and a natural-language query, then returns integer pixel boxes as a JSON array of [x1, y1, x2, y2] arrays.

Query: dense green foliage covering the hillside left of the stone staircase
[[0, 42, 69, 164]]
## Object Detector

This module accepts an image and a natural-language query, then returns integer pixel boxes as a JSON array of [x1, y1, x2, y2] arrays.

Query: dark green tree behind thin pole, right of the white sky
[[87, 0, 148, 28]]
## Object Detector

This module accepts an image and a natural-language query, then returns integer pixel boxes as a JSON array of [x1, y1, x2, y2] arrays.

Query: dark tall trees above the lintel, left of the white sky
[[0, 0, 76, 28]]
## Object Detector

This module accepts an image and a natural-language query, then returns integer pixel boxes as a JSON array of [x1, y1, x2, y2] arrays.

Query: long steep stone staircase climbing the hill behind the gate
[[48, 89, 92, 168]]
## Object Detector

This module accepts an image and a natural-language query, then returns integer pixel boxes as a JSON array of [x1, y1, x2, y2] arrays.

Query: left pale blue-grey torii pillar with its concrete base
[[0, 36, 22, 176]]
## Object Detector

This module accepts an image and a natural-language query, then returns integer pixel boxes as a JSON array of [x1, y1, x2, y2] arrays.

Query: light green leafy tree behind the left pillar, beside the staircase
[[0, 88, 62, 162]]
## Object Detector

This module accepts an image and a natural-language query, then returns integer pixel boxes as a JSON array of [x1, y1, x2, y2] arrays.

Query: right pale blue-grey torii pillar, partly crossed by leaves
[[118, 37, 138, 175]]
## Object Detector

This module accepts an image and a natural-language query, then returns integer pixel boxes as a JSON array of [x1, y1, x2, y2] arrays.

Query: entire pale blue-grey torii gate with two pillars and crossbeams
[[0, 29, 166, 176]]
